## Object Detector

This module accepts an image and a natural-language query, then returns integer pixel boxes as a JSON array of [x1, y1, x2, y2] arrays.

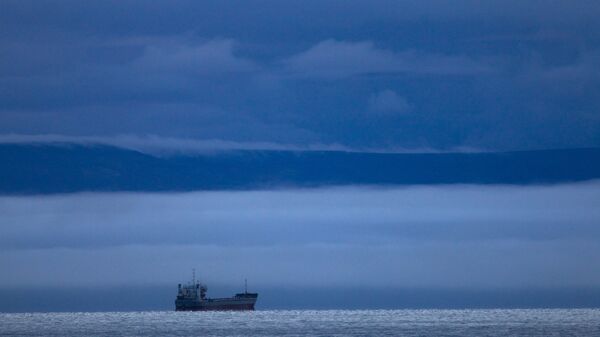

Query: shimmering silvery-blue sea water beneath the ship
[[0, 309, 600, 336]]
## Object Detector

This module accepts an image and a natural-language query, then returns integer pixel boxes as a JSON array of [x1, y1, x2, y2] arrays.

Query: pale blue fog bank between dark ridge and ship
[[0, 182, 600, 287]]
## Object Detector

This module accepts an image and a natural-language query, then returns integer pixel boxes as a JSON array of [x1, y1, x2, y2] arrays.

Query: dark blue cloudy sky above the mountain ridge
[[0, 0, 600, 150]]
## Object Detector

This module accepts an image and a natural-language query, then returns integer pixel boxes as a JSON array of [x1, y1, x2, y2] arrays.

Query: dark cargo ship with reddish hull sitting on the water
[[175, 277, 258, 311]]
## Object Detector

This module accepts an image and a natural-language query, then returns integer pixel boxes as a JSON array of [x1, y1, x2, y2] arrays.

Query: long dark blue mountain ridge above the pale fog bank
[[0, 144, 600, 194]]
